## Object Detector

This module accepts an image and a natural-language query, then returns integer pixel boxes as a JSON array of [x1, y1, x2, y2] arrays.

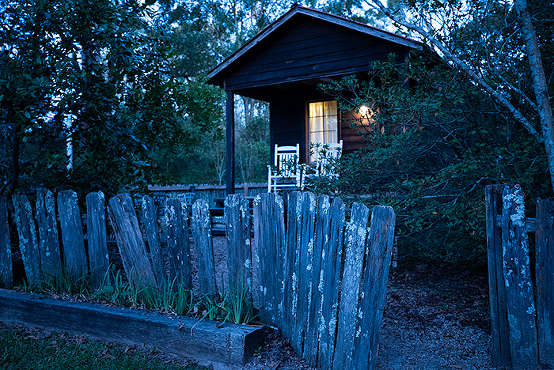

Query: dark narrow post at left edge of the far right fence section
[[485, 185, 512, 366]]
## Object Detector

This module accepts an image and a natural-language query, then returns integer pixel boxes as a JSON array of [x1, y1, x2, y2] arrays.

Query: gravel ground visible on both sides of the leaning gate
[[246, 265, 496, 370]]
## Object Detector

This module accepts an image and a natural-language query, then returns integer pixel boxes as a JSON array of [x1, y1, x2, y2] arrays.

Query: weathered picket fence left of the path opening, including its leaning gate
[[0, 191, 395, 369]]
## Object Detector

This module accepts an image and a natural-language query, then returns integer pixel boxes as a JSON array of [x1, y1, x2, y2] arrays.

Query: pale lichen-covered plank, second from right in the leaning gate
[[333, 203, 369, 369]]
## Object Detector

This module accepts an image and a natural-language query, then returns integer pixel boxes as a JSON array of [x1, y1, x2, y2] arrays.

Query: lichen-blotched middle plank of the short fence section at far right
[[502, 185, 538, 369]]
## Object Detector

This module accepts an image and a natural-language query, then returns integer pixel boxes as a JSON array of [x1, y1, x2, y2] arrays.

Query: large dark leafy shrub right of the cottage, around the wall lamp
[[319, 54, 550, 265]]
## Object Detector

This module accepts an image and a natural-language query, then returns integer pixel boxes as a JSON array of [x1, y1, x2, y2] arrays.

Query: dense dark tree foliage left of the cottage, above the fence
[[0, 0, 221, 198]]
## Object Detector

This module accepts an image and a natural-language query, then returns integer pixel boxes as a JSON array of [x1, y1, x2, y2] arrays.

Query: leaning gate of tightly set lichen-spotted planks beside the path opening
[[254, 192, 395, 369]]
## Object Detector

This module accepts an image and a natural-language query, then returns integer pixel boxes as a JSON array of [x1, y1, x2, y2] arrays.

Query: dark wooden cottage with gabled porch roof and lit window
[[205, 5, 422, 193]]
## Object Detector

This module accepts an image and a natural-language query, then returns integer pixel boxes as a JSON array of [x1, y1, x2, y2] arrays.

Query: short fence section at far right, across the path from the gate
[[485, 185, 554, 369]]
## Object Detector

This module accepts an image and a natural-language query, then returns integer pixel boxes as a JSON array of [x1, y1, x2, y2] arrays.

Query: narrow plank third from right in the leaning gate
[[319, 198, 346, 368]]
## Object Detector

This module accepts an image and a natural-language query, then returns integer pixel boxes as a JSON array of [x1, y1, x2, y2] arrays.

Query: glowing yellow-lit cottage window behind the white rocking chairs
[[308, 100, 339, 162]]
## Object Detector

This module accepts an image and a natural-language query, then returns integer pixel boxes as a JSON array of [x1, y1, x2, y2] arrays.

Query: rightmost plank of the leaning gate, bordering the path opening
[[352, 206, 396, 370]]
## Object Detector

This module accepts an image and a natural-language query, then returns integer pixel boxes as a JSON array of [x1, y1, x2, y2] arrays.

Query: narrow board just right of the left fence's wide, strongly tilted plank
[[141, 195, 165, 284]]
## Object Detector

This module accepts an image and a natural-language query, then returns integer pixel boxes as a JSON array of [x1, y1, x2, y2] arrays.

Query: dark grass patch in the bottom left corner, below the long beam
[[0, 327, 207, 370]]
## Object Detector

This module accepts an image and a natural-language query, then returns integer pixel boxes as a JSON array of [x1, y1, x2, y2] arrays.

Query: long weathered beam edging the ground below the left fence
[[0, 289, 265, 369]]
